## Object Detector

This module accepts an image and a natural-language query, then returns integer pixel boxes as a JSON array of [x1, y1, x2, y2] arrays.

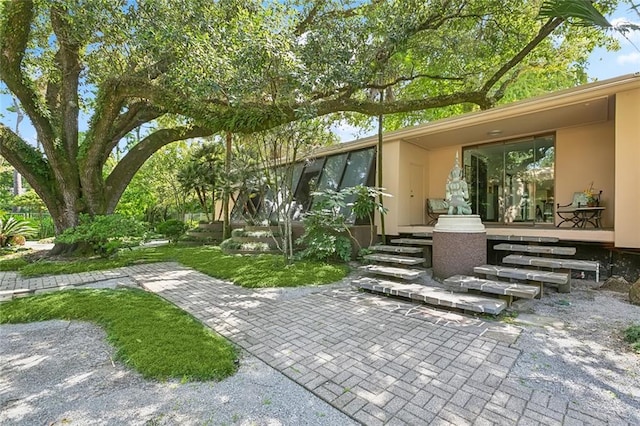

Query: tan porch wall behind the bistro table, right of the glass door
[[555, 120, 616, 228]]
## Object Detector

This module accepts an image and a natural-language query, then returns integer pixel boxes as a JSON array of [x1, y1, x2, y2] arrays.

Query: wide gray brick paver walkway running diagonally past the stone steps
[[0, 263, 626, 425]]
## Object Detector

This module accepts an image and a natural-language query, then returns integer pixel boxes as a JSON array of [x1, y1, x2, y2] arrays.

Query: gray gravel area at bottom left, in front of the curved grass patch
[[0, 321, 355, 425]]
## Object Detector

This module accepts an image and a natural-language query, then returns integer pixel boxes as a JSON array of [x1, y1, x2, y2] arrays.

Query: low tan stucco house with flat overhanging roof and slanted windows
[[232, 73, 640, 278]]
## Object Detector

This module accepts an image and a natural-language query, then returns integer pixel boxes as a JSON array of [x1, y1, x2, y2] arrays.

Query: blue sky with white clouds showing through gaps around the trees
[[0, 4, 640, 145]]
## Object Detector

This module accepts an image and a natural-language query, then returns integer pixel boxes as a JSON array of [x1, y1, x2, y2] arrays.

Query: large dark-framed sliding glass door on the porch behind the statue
[[463, 135, 555, 223]]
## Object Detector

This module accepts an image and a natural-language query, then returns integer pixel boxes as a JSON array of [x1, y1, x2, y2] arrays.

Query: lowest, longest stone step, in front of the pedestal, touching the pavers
[[354, 278, 507, 315]]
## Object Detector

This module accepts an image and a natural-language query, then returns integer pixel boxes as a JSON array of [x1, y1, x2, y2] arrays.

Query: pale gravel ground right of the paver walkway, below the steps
[[509, 281, 640, 425]]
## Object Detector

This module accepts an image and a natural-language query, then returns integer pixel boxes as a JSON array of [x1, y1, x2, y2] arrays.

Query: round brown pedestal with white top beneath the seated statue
[[433, 215, 487, 279]]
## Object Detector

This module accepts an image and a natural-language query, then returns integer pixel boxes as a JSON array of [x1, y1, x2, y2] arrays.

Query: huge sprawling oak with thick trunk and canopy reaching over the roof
[[0, 0, 632, 246]]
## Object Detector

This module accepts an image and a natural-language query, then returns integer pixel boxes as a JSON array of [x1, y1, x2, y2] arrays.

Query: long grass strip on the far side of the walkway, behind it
[[0, 245, 349, 288]]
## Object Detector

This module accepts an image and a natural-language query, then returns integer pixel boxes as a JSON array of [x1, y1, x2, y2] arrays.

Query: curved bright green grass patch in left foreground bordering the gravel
[[0, 289, 237, 381]]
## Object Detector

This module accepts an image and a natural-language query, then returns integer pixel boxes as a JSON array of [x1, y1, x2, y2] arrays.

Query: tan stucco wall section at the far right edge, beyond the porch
[[615, 89, 640, 248]]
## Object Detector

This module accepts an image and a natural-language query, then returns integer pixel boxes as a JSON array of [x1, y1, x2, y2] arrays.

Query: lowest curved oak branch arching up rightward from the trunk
[[105, 127, 215, 213]]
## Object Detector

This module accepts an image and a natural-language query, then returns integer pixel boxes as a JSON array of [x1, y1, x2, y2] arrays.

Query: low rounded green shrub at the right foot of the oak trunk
[[55, 214, 147, 256]]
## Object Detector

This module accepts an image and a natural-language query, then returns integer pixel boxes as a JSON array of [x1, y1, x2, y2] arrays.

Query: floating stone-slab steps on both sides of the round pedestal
[[354, 235, 600, 315]]
